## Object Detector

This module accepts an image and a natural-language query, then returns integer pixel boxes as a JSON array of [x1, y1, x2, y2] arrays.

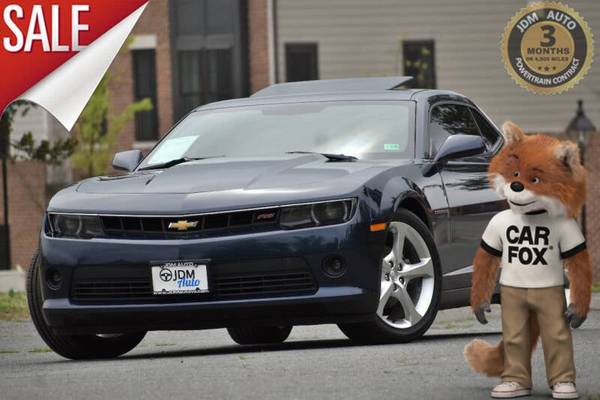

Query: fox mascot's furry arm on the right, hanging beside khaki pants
[[565, 250, 592, 328]]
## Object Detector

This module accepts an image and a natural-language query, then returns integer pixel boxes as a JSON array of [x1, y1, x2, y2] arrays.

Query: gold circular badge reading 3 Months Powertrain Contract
[[502, 2, 594, 94]]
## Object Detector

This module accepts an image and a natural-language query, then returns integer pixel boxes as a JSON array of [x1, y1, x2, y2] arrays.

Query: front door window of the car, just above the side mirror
[[429, 104, 479, 157]]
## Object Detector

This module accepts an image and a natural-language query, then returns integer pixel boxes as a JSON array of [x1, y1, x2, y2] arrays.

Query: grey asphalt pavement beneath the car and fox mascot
[[0, 307, 600, 400]]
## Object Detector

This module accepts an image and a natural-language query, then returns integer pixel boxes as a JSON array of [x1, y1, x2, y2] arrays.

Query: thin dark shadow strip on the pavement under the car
[[120, 332, 500, 360]]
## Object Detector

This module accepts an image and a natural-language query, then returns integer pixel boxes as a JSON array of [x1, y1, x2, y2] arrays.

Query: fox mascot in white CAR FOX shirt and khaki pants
[[465, 122, 592, 399]]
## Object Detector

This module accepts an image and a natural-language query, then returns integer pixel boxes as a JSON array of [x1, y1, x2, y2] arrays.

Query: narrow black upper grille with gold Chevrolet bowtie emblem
[[100, 208, 279, 238]]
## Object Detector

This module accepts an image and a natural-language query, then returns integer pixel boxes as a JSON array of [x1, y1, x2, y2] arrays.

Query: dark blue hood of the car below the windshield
[[49, 154, 412, 213]]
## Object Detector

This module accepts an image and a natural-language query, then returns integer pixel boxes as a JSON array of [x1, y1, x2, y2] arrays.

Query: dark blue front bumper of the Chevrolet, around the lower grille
[[41, 216, 384, 333]]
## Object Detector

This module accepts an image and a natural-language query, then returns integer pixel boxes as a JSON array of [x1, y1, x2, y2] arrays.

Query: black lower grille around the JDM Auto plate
[[71, 258, 317, 303]]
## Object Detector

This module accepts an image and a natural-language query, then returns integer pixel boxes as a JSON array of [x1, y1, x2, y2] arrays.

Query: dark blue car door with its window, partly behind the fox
[[429, 102, 505, 290]]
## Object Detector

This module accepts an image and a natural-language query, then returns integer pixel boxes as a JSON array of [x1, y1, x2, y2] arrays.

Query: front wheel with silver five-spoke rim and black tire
[[338, 209, 442, 343]]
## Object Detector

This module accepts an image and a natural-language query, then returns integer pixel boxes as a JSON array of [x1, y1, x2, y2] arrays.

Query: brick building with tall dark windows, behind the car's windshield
[[109, 0, 272, 155]]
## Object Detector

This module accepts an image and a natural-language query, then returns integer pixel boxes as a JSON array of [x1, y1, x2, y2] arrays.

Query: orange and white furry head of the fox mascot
[[488, 122, 586, 217]]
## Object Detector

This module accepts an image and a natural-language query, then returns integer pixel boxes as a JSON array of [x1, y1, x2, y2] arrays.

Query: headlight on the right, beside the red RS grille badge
[[279, 200, 354, 229]]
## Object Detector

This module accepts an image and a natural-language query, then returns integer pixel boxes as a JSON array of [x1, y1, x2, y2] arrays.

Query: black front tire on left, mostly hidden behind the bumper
[[26, 252, 146, 360]]
